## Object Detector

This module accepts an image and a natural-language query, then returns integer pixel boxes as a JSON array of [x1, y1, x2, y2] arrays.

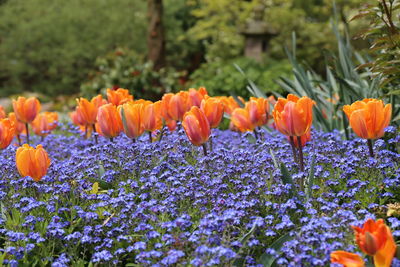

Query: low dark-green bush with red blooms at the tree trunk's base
[[81, 49, 186, 100]]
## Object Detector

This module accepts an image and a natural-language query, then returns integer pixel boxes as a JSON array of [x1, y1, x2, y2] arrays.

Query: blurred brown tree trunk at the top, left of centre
[[147, 0, 165, 70]]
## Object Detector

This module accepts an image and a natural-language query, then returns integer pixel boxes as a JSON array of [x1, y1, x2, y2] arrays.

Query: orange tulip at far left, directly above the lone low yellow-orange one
[[13, 96, 40, 123]]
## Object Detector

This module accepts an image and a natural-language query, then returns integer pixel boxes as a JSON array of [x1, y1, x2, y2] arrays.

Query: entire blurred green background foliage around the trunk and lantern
[[0, 0, 384, 102]]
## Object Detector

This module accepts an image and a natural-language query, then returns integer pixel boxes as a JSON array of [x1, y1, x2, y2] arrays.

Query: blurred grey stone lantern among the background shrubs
[[241, 4, 277, 62]]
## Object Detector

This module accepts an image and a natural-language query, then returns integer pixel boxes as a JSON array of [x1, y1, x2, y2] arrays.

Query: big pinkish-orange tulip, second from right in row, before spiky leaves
[[272, 94, 315, 136]]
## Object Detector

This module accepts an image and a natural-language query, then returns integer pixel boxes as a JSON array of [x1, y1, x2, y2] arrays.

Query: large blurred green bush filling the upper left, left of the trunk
[[0, 0, 146, 96]]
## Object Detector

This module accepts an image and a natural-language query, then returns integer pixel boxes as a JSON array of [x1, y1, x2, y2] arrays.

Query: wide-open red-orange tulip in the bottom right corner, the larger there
[[353, 219, 396, 267]]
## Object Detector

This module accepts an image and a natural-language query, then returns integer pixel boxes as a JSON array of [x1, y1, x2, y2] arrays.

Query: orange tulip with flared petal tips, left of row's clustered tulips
[[76, 95, 106, 125]]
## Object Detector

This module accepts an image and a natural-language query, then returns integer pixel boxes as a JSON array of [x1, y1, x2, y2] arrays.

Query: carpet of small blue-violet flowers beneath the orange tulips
[[0, 125, 400, 266]]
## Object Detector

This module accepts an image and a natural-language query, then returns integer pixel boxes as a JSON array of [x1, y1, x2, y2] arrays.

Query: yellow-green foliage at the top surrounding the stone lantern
[[188, 0, 373, 71]]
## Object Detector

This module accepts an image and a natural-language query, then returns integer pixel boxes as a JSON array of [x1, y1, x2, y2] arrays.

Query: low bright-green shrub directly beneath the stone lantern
[[190, 57, 291, 97]]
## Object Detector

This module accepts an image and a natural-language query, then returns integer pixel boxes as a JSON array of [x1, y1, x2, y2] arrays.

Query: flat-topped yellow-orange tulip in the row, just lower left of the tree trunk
[[118, 103, 145, 139]]
